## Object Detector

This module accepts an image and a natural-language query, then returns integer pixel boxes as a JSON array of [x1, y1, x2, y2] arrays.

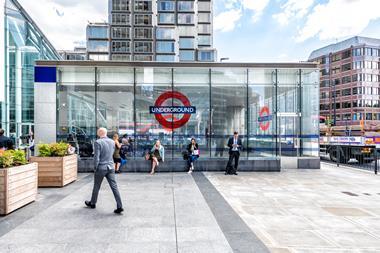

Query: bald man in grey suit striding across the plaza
[[85, 128, 124, 214]]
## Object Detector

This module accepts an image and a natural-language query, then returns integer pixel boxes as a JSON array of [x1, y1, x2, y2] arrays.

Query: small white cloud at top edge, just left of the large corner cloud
[[272, 0, 314, 26]]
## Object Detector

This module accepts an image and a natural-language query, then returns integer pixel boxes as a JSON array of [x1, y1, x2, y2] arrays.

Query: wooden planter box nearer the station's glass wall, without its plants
[[30, 155, 78, 187]]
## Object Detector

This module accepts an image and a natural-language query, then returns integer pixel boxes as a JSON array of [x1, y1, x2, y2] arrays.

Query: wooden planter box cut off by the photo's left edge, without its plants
[[0, 163, 38, 215]]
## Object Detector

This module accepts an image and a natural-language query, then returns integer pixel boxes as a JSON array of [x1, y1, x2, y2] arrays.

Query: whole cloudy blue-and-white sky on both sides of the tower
[[19, 0, 380, 62]]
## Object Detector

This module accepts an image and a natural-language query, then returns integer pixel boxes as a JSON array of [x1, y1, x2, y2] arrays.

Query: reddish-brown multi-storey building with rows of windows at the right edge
[[309, 37, 380, 128]]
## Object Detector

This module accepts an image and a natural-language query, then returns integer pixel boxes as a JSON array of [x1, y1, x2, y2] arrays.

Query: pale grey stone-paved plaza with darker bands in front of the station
[[0, 164, 380, 253]]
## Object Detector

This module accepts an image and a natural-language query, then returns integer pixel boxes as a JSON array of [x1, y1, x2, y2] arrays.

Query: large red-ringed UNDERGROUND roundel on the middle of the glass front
[[149, 91, 196, 129]]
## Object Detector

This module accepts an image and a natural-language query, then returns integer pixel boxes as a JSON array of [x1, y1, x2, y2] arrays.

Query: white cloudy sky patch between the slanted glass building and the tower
[[19, 0, 108, 49]]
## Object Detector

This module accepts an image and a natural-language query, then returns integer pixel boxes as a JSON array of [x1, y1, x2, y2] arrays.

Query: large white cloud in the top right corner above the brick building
[[296, 0, 380, 42]]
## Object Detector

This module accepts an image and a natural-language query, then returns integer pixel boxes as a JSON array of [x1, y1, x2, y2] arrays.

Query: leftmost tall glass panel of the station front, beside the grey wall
[[57, 67, 97, 157]]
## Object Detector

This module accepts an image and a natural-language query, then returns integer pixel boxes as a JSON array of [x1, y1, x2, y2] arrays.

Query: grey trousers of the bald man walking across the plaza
[[91, 167, 123, 208]]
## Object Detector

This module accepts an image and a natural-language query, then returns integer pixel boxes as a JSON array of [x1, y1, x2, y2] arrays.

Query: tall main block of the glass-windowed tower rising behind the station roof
[[109, 0, 216, 62]]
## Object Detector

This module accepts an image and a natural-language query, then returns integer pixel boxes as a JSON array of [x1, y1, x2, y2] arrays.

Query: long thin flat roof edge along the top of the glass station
[[36, 60, 318, 69]]
